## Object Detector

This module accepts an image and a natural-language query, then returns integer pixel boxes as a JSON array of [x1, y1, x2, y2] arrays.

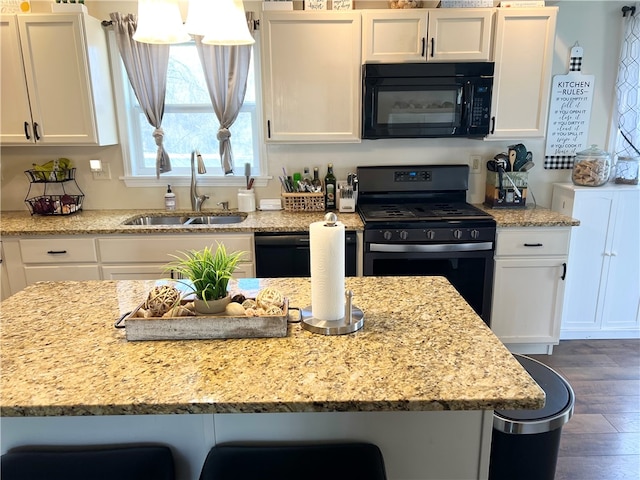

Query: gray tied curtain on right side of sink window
[[194, 35, 252, 175]]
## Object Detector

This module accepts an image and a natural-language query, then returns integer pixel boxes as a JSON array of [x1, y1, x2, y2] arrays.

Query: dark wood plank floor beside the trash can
[[530, 339, 640, 480]]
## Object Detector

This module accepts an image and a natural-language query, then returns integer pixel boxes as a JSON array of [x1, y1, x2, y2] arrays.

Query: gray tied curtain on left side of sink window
[[109, 12, 171, 178]]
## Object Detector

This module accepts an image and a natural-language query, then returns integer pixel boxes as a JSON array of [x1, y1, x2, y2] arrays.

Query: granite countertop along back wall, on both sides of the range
[[0, 205, 579, 236]]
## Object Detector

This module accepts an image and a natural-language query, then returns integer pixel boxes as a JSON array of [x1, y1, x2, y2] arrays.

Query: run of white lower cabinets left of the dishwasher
[[2, 233, 255, 296]]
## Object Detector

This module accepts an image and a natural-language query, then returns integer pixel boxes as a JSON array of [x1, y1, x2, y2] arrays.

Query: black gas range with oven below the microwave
[[357, 165, 496, 324]]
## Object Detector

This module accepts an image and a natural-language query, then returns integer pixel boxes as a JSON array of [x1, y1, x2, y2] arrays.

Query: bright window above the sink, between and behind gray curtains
[[112, 35, 266, 186]]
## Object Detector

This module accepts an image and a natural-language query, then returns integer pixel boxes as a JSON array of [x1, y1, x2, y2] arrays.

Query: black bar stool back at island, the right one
[[199, 443, 387, 480]]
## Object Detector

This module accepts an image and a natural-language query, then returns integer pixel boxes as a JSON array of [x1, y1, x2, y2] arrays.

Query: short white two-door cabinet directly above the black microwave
[[362, 8, 495, 63]]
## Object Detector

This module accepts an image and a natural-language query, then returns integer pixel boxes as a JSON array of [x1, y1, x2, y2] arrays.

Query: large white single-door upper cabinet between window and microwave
[[260, 11, 361, 143]]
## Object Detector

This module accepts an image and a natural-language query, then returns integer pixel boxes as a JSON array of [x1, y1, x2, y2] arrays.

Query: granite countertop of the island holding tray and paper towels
[[0, 277, 545, 416]]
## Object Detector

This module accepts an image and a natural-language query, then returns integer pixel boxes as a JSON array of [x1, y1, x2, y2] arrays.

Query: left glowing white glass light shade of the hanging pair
[[133, 0, 191, 44]]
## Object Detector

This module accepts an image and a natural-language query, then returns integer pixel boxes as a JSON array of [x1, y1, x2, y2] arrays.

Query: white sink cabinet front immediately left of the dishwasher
[[98, 233, 255, 280]]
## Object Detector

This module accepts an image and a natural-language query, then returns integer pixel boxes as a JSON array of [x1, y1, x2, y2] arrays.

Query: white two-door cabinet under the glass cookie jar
[[551, 183, 640, 339]]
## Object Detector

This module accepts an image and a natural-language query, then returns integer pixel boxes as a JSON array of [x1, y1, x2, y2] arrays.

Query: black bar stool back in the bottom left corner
[[0, 445, 175, 480]]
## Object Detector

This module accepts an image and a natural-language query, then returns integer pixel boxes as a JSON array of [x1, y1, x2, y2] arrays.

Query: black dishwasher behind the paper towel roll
[[255, 232, 357, 278]]
